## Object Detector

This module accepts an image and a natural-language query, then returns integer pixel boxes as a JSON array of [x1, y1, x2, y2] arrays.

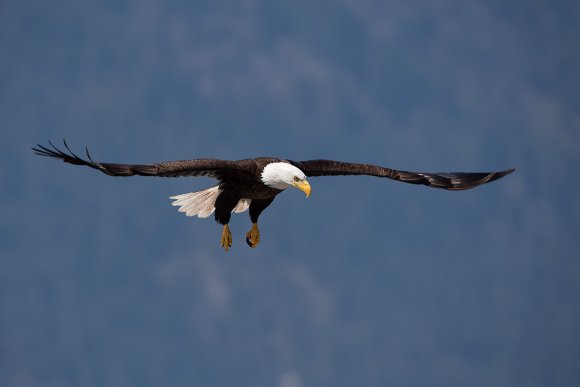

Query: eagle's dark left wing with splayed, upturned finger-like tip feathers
[[32, 141, 241, 178]]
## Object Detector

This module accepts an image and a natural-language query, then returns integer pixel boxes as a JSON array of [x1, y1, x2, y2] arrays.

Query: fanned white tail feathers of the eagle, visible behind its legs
[[170, 185, 252, 218]]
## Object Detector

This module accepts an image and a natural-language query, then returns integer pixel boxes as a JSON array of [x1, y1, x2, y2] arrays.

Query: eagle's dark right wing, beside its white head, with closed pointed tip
[[294, 160, 515, 190]]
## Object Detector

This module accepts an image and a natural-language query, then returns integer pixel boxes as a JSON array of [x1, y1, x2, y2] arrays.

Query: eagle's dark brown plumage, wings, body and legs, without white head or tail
[[32, 142, 514, 250]]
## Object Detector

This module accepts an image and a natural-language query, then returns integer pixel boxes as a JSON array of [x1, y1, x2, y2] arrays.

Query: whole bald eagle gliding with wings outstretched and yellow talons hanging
[[32, 141, 514, 251]]
